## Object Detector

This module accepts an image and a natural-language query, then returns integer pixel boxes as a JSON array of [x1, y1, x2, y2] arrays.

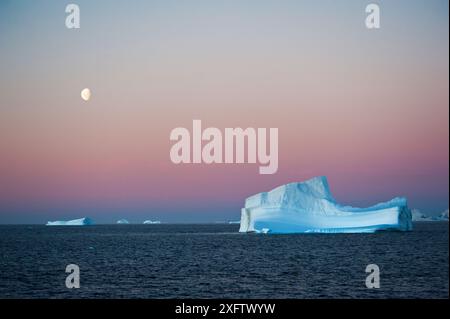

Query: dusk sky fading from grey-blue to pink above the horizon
[[0, 0, 449, 224]]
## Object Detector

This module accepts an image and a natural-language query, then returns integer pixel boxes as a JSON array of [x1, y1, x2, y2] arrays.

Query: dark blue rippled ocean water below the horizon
[[0, 222, 449, 298]]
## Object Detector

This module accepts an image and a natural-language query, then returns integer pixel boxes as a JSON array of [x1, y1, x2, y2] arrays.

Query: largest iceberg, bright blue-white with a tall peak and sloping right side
[[239, 176, 412, 234]]
